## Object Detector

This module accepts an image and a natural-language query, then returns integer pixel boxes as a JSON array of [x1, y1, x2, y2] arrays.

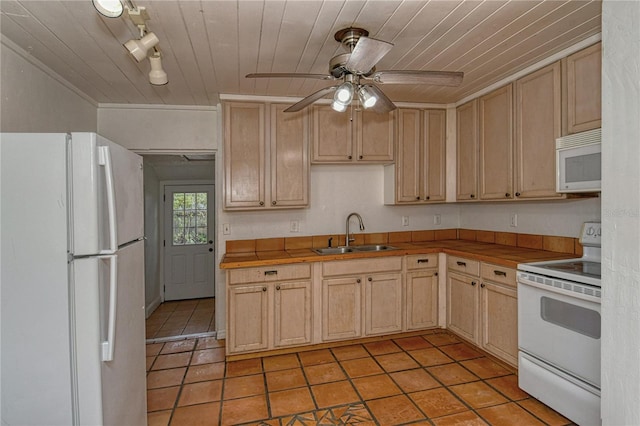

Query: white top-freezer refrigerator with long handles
[[0, 133, 146, 426]]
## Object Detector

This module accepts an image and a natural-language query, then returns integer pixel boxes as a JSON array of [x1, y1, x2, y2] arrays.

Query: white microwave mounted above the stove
[[556, 129, 602, 193]]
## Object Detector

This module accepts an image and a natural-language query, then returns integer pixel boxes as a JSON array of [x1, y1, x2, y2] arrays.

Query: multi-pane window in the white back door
[[172, 192, 208, 246]]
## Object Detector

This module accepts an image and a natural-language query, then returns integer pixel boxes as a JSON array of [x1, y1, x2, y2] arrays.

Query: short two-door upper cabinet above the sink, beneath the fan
[[311, 105, 395, 164]]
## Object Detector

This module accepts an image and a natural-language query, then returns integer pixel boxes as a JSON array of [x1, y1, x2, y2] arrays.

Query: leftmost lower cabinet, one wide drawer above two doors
[[226, 265, 313, 354]]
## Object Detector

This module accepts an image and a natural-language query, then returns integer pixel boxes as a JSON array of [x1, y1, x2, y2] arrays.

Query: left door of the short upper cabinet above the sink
[[312, 105, 353, 163]]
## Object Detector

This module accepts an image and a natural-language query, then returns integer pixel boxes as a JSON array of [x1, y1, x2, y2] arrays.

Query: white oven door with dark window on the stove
[[518, 273, 601, 389]]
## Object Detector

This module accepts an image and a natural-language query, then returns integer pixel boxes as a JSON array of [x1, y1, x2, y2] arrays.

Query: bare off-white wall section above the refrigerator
[[0, 37, 97, 132]]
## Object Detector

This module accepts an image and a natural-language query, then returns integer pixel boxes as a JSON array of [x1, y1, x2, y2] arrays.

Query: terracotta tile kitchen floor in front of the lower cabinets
[[147, 330, 571, 426]]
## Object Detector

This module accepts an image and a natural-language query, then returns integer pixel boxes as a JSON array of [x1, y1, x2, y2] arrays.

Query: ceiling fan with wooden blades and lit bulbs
[[246, 28, 463, 112]]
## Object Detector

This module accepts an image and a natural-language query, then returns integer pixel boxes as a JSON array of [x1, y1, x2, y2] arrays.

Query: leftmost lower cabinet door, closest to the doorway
[[227, 285, 269, 353]]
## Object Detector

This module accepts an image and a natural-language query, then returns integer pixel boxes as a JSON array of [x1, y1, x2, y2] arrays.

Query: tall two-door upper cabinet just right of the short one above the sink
[[385, 108, 446, 204]]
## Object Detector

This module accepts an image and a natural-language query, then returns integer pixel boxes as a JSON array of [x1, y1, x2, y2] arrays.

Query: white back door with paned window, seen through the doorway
[[164, 185, 215, 300]]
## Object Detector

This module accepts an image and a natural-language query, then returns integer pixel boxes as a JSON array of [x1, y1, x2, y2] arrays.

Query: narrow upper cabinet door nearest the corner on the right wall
[[456, 99, 478, 201]]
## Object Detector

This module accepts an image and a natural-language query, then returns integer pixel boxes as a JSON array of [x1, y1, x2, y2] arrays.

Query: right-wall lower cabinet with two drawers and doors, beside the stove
[[447, 256, 518, 366]]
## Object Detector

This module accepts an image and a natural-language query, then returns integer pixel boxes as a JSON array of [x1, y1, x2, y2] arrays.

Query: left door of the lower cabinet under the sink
[[322, 277, 362, 341]]
